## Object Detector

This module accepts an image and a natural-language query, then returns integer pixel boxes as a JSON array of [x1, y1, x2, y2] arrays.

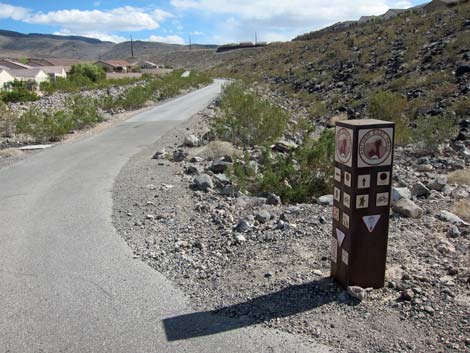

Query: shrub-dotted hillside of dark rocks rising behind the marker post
[[215, 3, 470, 138]]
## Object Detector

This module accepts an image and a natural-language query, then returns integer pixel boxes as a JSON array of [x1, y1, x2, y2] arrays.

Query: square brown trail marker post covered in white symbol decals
[[331, 119, 395, 288]]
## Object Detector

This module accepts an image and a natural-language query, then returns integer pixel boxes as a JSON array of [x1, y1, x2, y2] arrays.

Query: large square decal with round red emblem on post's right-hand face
[[357, 128, 393, 168]]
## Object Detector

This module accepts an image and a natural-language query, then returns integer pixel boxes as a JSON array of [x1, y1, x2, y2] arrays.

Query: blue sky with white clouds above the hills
[[0, 0, 426, 44]]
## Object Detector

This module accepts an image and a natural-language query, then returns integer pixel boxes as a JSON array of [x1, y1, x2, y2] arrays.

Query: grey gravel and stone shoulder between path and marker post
[[113, 104, 470, 353]]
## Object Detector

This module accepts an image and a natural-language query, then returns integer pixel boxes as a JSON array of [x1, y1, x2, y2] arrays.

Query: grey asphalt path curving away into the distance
[[0, 81, 338, 353]]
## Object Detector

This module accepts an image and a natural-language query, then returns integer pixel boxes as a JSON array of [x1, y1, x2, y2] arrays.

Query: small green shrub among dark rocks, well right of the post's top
[[413, 113, 458, 152]]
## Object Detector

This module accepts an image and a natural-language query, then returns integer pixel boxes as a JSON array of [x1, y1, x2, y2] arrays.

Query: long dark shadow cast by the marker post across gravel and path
[[163, 278, 348, 342]]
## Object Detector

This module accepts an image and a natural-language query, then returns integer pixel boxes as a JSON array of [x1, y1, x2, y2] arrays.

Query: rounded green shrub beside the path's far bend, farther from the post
[[213, 82, 289, 145]]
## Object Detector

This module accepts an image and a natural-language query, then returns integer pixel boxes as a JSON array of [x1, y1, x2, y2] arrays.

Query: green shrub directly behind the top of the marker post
[[368, 91, 411, 144]]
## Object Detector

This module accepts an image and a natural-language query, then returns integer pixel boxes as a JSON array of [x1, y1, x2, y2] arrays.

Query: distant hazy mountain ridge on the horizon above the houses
[[0, 30, 217, 60]]
